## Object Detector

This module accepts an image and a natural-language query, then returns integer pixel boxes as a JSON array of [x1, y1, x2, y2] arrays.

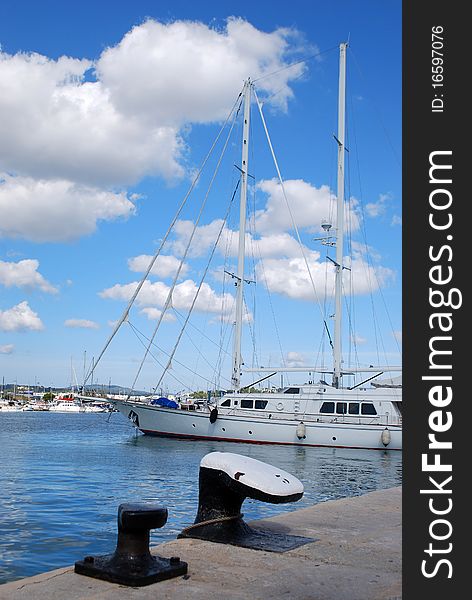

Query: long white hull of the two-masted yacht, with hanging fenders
[[113, 401, 402, 450]]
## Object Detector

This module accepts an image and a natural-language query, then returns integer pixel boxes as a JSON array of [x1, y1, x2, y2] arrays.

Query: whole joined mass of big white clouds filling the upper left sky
[[0, 18, 306, 242]]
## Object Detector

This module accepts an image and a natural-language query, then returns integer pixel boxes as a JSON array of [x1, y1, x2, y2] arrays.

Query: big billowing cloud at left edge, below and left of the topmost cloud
[[0, 53, 183, 185]]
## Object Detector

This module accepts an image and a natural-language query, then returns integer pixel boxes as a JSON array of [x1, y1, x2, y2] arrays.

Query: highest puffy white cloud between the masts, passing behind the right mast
[[256, 179, 359, 234]]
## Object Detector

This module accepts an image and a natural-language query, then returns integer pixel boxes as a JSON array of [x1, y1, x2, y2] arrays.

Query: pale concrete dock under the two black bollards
[[0, 487, 401, 600]]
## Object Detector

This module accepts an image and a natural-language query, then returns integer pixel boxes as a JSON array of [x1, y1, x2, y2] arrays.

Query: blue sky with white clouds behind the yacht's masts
[[0, 0, 402, 393]]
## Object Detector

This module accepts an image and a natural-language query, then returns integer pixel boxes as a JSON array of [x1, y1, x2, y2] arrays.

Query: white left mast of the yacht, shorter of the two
[[231, 79, 252, 390]]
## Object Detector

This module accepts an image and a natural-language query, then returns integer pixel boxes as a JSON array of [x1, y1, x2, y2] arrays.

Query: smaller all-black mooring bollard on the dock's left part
[[74, 504, 187, 586]]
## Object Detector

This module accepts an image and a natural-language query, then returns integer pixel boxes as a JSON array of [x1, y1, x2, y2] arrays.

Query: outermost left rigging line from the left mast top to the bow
[[83, 92, 242, 387]]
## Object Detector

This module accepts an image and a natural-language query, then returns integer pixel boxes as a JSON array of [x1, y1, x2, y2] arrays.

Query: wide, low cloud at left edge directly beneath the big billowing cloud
[[0, 175, 134, 242]]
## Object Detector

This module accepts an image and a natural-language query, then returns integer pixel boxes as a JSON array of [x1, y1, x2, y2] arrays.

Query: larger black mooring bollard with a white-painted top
[[178, 452, 314, 552]]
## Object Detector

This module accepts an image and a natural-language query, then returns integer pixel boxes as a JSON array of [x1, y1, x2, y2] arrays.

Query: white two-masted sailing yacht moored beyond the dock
[[96, 43, 402, 450]]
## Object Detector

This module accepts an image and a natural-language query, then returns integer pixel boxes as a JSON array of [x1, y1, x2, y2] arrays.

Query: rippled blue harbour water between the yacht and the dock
[[0, 412, 402, 583]]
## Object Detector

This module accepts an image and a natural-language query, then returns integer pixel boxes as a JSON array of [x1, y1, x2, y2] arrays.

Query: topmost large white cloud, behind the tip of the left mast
[[97, 18, 305, 127]]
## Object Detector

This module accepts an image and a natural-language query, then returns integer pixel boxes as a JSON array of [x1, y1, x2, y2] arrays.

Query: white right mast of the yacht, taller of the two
[[333, 42, 347, 388]]
